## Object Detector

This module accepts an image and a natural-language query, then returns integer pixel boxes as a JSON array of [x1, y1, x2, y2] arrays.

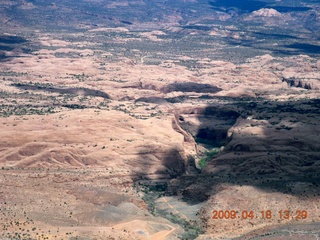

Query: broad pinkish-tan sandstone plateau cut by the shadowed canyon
[[0, 19, 320, 239]]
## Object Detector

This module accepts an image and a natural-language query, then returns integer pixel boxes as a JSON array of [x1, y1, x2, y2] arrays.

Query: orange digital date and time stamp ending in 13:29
[[212, 210, 308, 220]]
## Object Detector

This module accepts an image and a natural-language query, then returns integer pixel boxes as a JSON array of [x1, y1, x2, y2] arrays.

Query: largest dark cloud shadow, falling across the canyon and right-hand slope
[[131, 95, 320, 204]]
